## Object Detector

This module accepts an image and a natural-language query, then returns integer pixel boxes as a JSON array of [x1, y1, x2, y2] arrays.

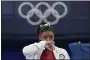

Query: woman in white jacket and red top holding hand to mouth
[[23, 23, 70, 60]]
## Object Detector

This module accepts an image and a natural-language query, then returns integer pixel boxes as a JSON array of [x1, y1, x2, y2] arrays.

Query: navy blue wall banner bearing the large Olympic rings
[[1, 1, 90, 35]]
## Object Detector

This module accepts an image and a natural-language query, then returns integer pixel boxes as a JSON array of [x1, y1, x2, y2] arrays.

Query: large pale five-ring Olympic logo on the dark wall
[[18, 2, 68, 25]]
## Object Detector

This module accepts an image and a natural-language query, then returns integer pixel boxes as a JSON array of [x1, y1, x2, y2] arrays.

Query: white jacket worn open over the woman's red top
[[23, 41, 70, 59]]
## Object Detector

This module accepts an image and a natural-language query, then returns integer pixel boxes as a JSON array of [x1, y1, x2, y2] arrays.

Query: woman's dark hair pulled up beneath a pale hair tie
[[37, 22, 53, 35]]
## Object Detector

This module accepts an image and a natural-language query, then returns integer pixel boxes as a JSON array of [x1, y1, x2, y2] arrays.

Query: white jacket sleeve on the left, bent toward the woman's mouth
[[22, 41, 46, 59]]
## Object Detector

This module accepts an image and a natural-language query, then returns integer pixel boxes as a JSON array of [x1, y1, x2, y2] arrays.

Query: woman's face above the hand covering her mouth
[[39, 31, 54, 41]]
